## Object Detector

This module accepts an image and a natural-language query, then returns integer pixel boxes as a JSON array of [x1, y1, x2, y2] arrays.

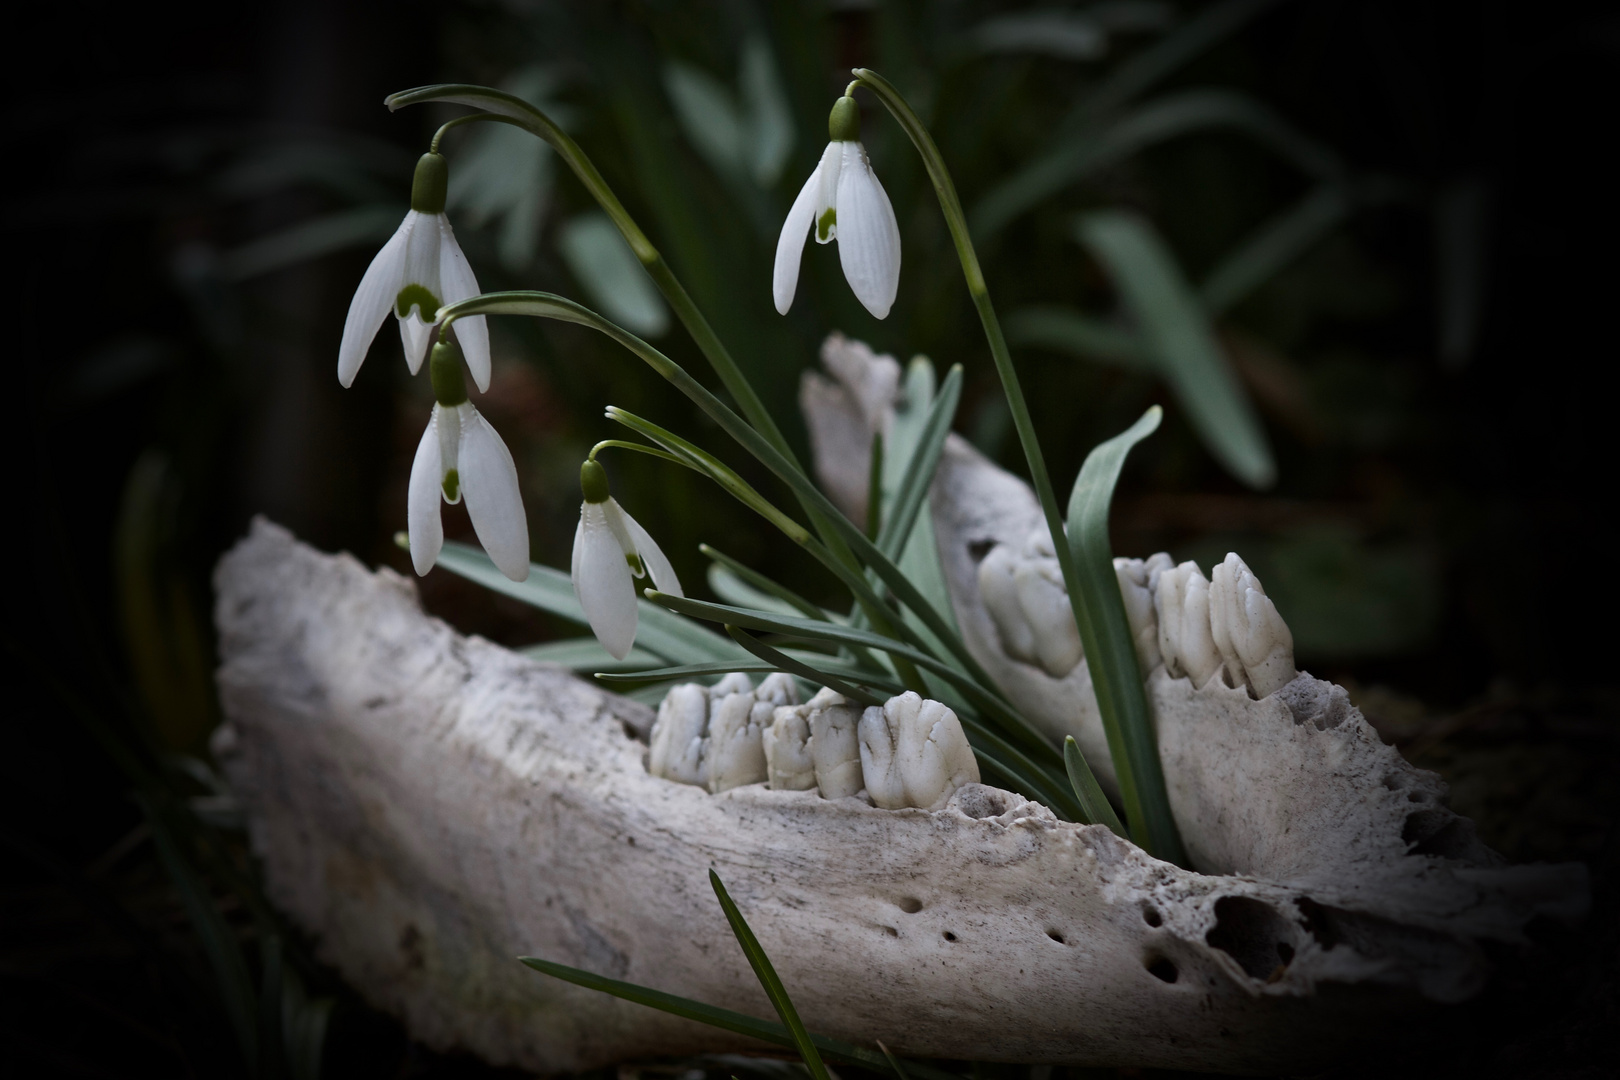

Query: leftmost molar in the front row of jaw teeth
[[646, 672, 799, 793]]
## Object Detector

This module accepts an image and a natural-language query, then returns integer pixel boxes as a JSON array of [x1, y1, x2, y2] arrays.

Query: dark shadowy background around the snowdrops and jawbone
[[0, 0, 1620, 1077]]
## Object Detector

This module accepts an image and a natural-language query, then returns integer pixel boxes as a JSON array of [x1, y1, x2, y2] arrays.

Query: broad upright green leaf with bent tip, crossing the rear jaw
[[1068, 405, 1186, 866]]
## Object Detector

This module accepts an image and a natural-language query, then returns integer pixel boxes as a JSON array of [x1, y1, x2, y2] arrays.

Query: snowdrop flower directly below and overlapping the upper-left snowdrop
[[407, 341, 528, 581]]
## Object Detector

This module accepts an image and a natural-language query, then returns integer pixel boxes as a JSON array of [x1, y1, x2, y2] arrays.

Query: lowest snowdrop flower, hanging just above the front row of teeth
[[573, 461, 685, 661]]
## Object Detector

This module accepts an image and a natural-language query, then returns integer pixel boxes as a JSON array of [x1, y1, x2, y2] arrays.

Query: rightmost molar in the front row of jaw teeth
[[860, 690, 978, 810]]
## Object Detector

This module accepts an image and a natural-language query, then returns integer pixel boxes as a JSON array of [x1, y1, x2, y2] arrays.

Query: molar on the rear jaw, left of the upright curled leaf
[[978, 528, 1084, 678]]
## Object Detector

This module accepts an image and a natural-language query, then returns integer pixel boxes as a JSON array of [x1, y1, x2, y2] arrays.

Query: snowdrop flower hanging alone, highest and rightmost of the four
[[771, 96, 901, 319]]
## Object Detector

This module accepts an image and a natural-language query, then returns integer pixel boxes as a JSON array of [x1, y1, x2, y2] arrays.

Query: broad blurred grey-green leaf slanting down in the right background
[[1077, 210, 1277, 487]]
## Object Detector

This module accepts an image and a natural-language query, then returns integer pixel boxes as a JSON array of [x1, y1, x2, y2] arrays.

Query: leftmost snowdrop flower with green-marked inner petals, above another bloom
[[337, 152, 489, 392]]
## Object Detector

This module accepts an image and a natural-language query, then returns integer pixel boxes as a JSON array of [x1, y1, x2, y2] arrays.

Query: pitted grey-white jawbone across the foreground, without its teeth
[[215, 521, 1584, 1072]]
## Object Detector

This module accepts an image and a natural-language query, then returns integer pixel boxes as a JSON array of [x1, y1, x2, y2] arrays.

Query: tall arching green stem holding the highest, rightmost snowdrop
[[854, 68, 1173, 857]]
